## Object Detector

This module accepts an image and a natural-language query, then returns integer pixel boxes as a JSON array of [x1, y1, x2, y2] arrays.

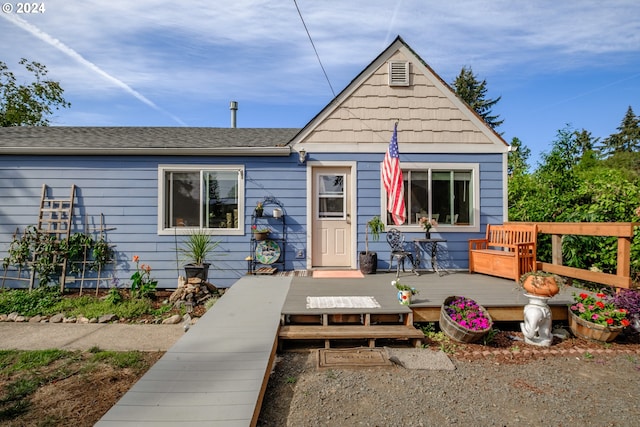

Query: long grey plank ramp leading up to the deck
[[96, 276, 292, 427]]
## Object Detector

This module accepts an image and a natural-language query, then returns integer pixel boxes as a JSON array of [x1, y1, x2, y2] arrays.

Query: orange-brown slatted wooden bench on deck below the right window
[[469, 224, 537, 281]]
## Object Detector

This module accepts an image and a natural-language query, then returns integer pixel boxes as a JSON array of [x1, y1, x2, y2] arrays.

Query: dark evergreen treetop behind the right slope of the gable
[[451, 67, 504, 129]]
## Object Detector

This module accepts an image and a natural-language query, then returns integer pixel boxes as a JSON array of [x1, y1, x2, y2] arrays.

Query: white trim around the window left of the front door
[[158, 165, 245, 236]]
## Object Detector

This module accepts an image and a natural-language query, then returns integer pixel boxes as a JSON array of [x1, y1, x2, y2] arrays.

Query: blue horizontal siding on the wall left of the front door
[[0, 156, 306, 288]]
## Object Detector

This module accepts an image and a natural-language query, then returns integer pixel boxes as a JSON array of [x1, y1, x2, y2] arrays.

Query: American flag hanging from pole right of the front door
[[382, 123, 406, 225]]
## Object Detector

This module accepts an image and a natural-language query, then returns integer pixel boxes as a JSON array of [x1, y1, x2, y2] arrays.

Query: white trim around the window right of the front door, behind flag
[[380, 162, 480, 233]]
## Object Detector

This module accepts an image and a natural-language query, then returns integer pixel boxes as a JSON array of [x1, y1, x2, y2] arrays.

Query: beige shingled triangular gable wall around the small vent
[[292, 36, 508, 152]]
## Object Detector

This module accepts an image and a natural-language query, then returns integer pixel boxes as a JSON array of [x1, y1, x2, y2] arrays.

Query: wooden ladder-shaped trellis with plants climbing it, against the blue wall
[[29, 184, 76, 292]]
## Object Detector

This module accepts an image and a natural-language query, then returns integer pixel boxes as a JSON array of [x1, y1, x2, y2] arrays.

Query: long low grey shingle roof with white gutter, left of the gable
[[0, 126, 299, 156]]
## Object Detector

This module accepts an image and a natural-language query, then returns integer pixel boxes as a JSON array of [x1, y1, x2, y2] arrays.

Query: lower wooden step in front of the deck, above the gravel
[[278, 325, 424, 348]]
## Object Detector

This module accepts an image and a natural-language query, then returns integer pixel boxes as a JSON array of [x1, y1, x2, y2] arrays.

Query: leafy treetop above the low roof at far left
[[0, 58, 71, 127]]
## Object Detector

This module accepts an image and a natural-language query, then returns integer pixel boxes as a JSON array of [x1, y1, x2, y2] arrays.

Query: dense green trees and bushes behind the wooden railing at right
[[508, 126, 640, 280]]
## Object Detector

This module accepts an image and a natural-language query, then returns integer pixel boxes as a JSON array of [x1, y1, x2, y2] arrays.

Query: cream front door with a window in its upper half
[[311, 167, 352, 267]]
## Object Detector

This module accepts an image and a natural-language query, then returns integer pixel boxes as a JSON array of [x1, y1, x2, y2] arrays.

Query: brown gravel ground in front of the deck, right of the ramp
[[258, 337, 640, 427]]
